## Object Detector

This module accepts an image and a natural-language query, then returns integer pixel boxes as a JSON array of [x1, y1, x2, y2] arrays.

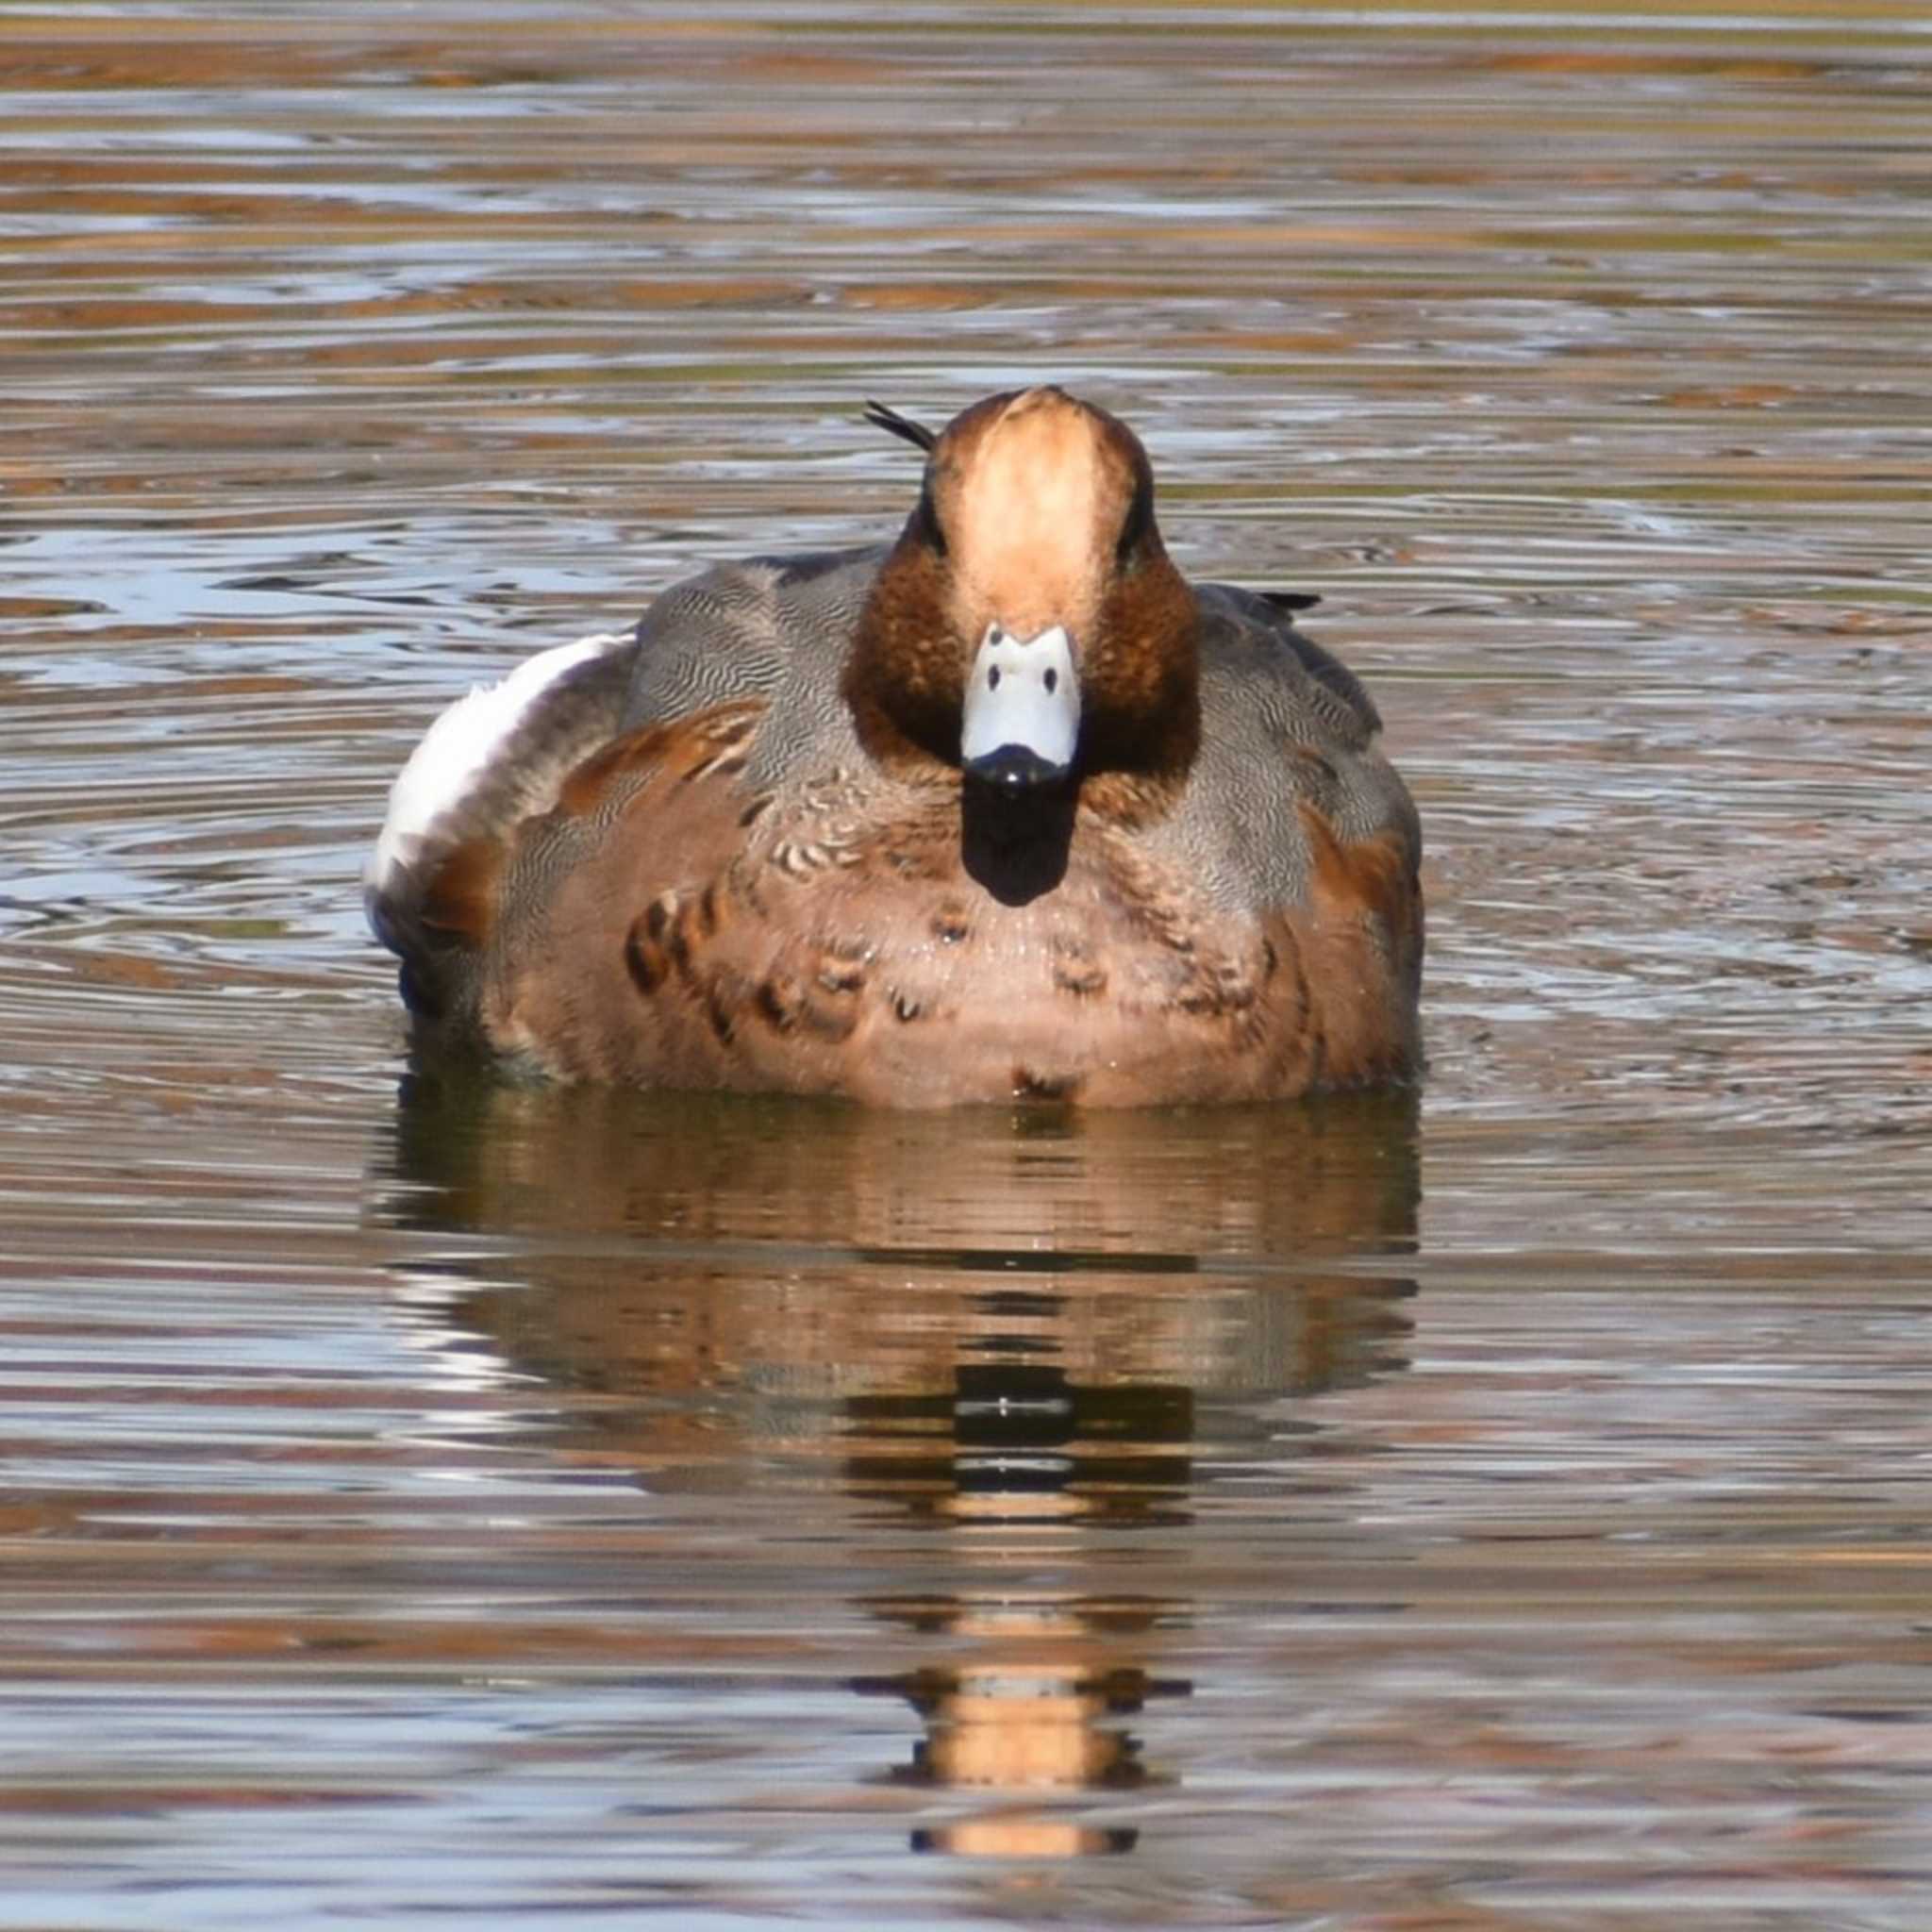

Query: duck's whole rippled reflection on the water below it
[[373, 1080, 1418, 1857]]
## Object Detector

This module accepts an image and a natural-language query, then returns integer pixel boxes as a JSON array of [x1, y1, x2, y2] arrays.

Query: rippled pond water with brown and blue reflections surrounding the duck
[[0, 0, 1932, 1932]]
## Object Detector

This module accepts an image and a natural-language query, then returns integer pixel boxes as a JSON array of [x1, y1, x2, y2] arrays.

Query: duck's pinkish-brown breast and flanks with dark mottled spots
[[459, 715, 1414, 1108]]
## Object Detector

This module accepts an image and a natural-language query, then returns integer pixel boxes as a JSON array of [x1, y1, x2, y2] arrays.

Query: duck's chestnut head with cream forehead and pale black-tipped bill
[[844, 387, 1200, 794]]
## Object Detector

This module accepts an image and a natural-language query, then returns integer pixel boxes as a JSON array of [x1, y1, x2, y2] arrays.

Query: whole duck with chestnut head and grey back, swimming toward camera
[[365, 385, 1424, 1109]]
